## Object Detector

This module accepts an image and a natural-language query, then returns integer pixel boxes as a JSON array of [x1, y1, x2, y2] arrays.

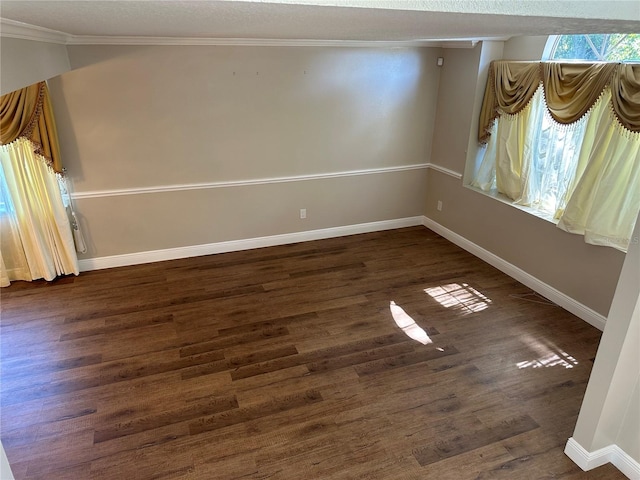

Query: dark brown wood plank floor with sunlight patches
[[0, 227, 625, 480]]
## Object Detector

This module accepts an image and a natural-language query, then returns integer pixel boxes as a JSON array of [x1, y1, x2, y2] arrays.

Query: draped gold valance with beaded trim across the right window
[[478, 60, 640, 144]]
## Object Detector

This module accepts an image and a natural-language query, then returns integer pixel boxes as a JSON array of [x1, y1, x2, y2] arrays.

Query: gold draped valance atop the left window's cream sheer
[[0, 82, 62, 173]]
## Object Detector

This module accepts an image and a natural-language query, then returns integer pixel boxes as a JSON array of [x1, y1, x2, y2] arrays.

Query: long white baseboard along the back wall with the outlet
[[79, 216, 423, 272]]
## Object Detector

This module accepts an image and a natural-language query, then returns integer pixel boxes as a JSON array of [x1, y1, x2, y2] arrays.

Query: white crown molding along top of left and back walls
[[0, 18, 488, 48]]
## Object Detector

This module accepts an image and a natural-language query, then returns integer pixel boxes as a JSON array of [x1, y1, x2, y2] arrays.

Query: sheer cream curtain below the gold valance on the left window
[[0, 138, 79, 286]]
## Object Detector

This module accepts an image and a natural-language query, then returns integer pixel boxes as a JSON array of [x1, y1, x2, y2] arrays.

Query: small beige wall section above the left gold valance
[[0, 37, 69, 95]]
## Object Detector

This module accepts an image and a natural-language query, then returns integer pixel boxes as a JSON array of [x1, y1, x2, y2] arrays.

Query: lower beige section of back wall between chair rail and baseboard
[[76, 170, 425, 258]]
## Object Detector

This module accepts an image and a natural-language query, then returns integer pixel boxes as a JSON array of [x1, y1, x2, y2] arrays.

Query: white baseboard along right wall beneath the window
[[422, 217, 606, 330]]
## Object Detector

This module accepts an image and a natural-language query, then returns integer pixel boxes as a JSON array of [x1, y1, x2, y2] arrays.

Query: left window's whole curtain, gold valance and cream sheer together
[[0, 82, 79, 286]]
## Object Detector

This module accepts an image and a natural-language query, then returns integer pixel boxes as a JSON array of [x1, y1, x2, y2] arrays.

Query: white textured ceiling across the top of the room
[[0, 0, 640, 43]]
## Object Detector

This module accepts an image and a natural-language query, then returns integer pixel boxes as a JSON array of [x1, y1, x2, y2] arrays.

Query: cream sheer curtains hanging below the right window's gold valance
[[471, 86, 640, 251]]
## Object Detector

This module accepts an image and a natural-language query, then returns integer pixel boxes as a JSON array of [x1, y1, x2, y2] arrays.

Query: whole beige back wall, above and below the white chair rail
[[50, 46, 440, 258]]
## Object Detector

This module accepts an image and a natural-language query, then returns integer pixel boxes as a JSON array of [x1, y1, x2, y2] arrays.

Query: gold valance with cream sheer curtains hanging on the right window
[[471, 37, 640, 251]]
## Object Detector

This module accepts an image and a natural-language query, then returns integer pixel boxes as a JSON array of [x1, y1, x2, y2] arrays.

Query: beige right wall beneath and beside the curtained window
[[425, 39, 624, 316]]
